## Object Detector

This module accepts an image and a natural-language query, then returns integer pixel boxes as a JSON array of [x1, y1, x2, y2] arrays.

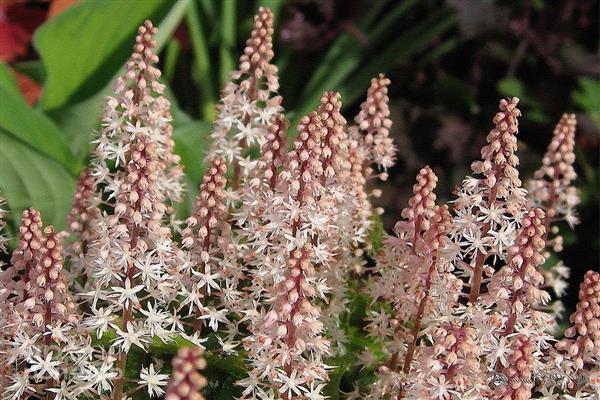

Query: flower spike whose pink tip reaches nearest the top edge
[[209, 7, 282, 189]]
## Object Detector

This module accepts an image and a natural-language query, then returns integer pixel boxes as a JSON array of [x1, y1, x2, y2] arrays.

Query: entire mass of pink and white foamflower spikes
[[0, 8, 600, 400]]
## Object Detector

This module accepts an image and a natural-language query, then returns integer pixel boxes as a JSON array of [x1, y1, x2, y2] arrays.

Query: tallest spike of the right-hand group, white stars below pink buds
[[450, 97, 526, 303]]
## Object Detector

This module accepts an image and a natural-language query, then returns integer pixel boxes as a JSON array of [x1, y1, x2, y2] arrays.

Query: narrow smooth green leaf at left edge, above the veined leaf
[[0, 85, 79, 174]]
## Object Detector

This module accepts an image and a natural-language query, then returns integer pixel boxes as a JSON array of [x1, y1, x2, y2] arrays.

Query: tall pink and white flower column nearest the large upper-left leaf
[[85, 21, 191, 400]]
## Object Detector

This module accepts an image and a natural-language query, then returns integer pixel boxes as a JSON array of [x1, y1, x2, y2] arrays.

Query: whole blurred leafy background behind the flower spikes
[[0, 0, 600, 399]]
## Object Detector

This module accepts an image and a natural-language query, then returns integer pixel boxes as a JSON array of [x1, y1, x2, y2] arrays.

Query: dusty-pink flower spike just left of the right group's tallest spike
[[367, 167, 460, 398]]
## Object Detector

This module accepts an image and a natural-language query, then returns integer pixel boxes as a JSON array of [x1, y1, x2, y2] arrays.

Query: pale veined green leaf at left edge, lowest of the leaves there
[[0, 128, 75, 234]]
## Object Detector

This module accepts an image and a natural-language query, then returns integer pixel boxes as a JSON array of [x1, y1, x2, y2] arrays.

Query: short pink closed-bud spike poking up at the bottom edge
[[165, 347, 206, 400]]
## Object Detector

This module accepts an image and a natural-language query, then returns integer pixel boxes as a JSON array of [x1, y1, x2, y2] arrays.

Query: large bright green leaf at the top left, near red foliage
[[34, 0, 174, 109]]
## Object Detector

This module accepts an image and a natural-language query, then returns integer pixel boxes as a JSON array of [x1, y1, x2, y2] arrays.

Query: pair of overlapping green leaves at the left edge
[[0, 64, 80, 233]]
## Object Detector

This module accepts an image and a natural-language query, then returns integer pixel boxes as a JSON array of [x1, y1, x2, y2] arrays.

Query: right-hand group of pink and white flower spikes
[[363, 98, 600, 400]]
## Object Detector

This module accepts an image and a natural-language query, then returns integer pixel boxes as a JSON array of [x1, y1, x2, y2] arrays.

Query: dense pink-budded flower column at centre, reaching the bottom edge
[[242, 104, 331, 399]]
